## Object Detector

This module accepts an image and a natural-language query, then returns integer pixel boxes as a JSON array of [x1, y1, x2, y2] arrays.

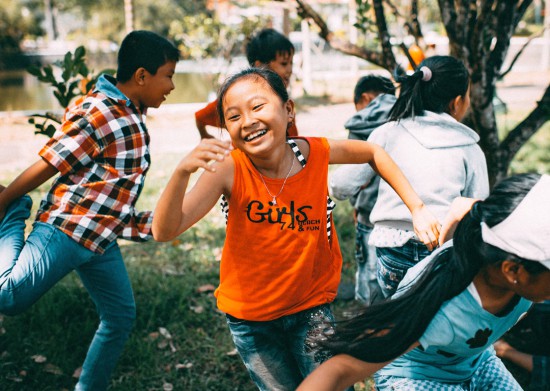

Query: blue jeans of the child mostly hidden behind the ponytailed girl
[[355, 223, 381, 304]]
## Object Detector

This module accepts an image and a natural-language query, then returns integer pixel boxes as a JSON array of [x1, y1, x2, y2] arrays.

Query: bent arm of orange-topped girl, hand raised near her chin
[[153, 138, 233, 242]]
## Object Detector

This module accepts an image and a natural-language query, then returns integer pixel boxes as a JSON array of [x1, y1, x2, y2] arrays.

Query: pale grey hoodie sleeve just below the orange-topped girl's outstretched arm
[[329, 163, 376, 200]]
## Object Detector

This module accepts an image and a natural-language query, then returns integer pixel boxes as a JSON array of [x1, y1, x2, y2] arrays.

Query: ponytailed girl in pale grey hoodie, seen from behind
[[330, 56, 489, 297]]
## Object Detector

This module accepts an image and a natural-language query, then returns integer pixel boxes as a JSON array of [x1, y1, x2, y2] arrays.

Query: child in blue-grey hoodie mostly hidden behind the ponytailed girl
[[344, 75, 396, 304]]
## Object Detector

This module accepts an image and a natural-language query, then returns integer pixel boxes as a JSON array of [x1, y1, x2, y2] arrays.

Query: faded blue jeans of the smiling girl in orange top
[[227, 305, 334, 391]]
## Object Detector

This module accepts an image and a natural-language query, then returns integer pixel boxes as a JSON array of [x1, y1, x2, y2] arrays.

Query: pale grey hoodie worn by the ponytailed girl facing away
[[330, 111, 489, 231]]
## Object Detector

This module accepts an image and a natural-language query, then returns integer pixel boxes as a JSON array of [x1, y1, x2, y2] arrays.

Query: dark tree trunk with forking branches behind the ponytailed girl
[[287, 0, 550, 184]]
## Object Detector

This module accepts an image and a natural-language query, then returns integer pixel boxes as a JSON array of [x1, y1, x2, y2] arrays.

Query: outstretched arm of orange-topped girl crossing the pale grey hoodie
[[328, 140, 440, 251]]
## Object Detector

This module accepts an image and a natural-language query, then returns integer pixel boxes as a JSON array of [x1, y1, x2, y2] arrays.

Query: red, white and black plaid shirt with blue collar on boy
[[37, 76, 152, 254]]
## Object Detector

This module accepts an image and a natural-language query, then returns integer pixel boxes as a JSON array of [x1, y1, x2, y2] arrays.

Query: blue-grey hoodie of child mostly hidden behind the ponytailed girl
[[344, 94, 397, 226]]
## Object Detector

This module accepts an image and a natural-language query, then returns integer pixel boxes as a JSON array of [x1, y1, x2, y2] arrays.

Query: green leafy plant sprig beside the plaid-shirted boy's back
[[27, 46, 115, 137]]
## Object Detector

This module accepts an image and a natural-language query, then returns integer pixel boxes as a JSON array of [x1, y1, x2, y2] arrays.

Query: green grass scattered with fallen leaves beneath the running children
[[0, 106, 550, 391]]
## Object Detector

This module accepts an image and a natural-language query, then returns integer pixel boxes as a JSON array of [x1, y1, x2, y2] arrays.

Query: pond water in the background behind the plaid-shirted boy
[[0, 70, 217, 111]]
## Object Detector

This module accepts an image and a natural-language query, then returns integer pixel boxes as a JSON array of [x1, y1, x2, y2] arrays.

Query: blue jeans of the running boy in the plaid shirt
[[0, 196, 136, 391]]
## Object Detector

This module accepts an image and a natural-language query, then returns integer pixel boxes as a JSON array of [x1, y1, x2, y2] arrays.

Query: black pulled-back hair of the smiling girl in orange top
[[216, 68, 289, 127]]
